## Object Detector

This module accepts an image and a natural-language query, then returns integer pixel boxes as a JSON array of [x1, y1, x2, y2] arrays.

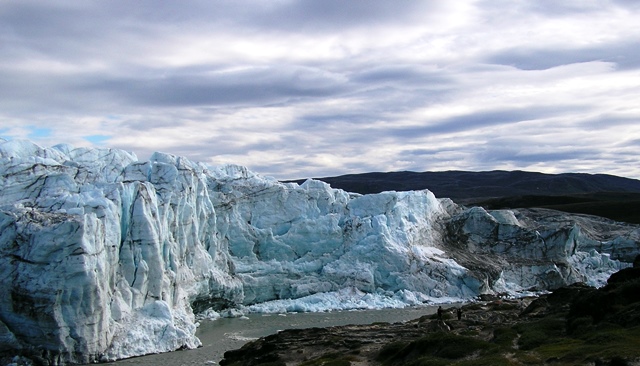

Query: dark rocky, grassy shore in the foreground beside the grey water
[[220, 261, 640, 366]]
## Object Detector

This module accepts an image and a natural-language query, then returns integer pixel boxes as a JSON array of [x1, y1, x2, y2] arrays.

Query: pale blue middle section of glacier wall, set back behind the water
[[216, 173, 481, 304]]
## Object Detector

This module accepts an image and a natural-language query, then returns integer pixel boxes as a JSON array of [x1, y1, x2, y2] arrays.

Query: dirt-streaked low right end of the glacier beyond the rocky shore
[[447, 207, 640, 293]]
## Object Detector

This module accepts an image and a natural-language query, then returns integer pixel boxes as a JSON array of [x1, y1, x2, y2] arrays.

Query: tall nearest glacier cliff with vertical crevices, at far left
[[0, 141, 242, 363]]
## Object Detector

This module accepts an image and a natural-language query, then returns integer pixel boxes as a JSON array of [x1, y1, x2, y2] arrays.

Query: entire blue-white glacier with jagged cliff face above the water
[[0, 139, 640, 364]]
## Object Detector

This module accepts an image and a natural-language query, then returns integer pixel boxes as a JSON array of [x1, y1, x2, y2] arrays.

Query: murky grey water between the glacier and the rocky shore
[[106, 305, 454, 366]]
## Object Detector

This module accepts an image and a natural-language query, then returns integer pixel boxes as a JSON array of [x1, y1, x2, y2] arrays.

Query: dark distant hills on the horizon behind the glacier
[[294, 170, 640, 223]]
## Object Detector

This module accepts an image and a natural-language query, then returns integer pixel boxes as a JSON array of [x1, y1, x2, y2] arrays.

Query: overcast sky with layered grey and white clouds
[[0, 0, 640, 179]]
